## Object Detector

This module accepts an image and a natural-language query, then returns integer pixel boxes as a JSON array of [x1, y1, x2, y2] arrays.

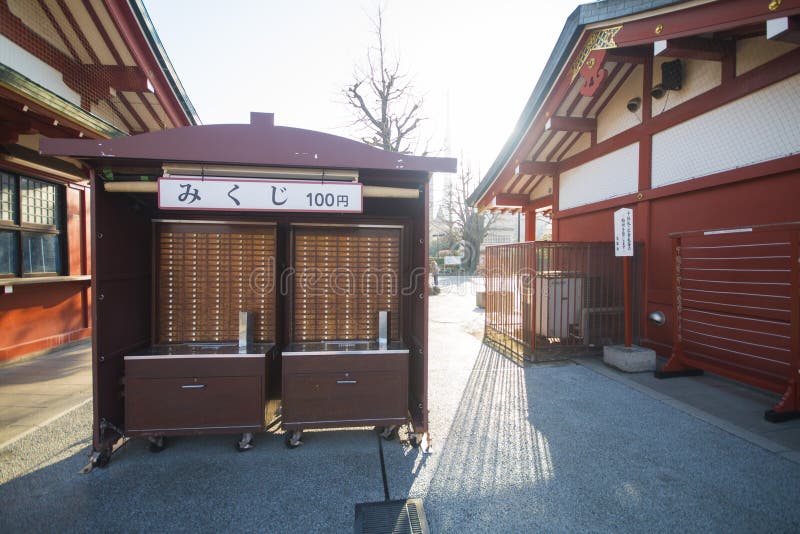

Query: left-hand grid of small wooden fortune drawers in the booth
[[156, 223, 276, 343]]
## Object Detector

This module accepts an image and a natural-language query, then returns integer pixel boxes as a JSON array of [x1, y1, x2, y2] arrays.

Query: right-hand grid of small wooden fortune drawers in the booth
[[292, 226, 401, 341]]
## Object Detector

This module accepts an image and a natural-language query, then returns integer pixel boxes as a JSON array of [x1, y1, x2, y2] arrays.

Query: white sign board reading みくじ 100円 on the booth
[[158, 176, 362, 213]]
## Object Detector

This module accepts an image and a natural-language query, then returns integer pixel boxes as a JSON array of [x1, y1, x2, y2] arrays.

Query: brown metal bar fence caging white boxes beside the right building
[[485, 242, 642, 361]]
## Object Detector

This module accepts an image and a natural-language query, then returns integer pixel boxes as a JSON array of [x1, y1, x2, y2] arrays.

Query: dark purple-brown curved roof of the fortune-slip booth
[[40, 113, 456, 172]]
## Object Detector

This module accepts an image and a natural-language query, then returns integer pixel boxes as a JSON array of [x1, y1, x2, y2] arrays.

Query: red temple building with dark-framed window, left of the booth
[[0, 0, 196, 362]]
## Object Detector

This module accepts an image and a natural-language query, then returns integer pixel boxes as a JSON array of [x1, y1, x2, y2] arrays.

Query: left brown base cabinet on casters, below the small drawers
[[125, 354, 267, 435]]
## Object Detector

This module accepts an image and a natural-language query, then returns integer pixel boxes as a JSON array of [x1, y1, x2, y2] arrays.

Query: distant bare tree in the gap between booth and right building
[[442, 168, 497, 273]]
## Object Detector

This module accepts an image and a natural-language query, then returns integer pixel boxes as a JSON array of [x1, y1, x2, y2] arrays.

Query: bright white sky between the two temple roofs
[[145, 0, 585, 188]]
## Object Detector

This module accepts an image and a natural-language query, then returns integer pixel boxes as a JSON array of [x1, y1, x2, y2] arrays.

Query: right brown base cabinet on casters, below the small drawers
[[283, 353, 408, 429]]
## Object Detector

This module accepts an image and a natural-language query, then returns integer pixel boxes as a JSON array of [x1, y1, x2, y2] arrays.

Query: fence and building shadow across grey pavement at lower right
[[395, 345, 800, 532]]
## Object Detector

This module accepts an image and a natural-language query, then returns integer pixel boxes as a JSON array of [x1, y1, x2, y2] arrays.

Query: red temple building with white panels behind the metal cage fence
[[471, 0, 800, 418]]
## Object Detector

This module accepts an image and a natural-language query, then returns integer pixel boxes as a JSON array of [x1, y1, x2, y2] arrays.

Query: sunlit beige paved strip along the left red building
[[0, 339, 92, 449]]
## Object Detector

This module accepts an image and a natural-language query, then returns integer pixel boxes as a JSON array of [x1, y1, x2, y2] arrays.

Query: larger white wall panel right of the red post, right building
[[652, 75, 800, 187]]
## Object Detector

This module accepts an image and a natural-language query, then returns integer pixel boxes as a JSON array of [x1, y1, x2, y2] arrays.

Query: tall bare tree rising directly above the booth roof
[[342, 6, 425, 154]]
